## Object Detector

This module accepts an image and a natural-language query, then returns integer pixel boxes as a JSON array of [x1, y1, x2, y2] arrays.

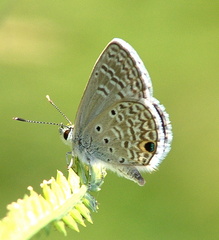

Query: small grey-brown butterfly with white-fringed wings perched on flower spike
[[60, 38, 172, 186]]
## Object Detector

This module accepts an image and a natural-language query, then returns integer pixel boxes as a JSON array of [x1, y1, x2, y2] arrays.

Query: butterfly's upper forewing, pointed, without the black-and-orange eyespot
[[75, 38, 152, 131]]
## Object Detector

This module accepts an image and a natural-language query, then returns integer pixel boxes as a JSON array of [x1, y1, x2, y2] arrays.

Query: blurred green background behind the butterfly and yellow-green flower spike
[[0, 0, 219, 240]]
